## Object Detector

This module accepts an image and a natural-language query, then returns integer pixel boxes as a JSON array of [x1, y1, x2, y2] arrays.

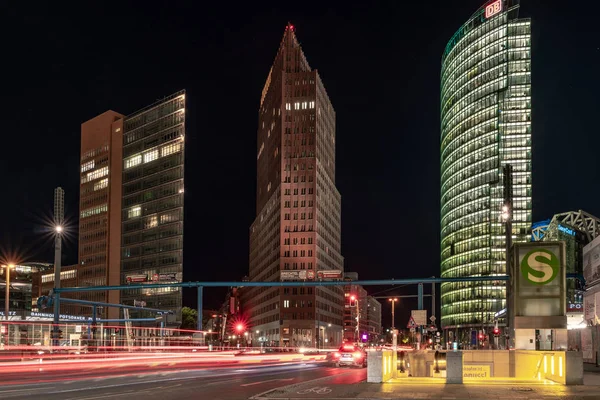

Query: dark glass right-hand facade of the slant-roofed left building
[[120, 91, 185, 325]]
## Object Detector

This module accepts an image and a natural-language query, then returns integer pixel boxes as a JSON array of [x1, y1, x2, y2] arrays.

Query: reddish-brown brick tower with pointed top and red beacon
[[243, 24, 344, 347]]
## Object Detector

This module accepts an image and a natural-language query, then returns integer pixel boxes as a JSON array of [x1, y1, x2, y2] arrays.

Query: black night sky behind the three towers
[[0, 0, 600, 325]]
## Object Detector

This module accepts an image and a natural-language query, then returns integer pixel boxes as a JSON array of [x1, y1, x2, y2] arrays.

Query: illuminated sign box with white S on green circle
[[513, 242, 566, 318]]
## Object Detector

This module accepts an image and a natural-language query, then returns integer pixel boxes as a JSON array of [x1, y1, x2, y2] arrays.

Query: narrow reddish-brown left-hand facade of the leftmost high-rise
[[78, 111, 123, 318]]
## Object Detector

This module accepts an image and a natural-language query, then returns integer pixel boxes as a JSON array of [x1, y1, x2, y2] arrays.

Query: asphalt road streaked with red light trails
[[0, 362, 366, 400]]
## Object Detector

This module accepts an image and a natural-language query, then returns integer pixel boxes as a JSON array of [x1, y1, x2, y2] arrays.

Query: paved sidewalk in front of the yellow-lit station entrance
[[251, 373, 600, 400]]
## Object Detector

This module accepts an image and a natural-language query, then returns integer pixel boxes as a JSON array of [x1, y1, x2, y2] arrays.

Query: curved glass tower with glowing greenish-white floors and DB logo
[[440, 0, 532, 341]]
